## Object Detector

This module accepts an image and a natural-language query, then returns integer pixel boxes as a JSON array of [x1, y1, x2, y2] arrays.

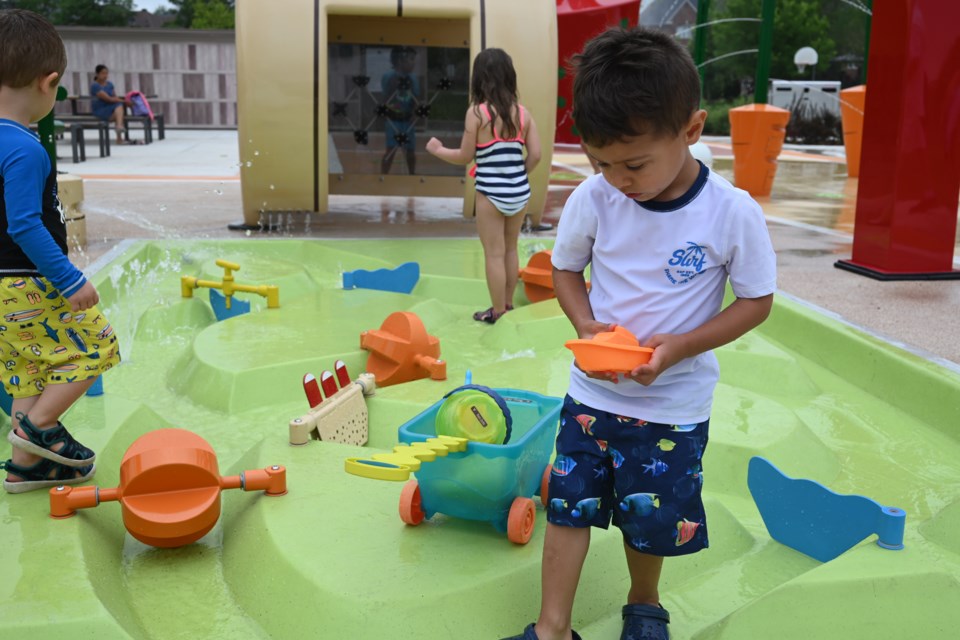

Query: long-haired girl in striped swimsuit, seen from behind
[[427, 49, 540, 324]]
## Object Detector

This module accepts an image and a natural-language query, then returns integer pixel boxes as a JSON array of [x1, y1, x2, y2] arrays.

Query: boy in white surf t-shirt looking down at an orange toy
[[506, 28, 776, 640]]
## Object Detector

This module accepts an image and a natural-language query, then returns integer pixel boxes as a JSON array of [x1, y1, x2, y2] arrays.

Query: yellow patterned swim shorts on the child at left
[[0, 277, 120, 398]]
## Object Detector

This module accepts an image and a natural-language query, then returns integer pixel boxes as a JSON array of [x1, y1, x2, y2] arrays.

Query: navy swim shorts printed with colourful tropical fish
[[547, 395, 710, 556]]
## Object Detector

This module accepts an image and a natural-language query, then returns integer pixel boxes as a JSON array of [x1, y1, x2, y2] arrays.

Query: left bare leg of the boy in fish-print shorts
[[534, 522, 590, 640]]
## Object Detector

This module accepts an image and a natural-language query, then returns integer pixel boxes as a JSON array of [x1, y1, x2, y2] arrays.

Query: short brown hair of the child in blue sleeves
[[0, 9, 67, 89]]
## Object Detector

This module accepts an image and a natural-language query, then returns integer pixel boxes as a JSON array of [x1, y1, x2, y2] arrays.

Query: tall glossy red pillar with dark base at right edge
[[835, 0, 960, 280]]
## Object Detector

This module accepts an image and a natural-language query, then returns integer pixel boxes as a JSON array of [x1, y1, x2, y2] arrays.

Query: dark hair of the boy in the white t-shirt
[[573, 27, 700, 147]]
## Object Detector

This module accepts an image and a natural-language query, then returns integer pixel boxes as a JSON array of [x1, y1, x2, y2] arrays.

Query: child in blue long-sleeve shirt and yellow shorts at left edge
[[0, 9, 120, 493]]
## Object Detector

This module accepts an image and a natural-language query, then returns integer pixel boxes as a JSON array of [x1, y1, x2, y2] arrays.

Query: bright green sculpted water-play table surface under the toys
[[0, 240, 960, 640]]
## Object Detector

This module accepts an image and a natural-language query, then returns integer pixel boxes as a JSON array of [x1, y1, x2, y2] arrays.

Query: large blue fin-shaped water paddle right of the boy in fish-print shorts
[[747, 456, 907, 562]]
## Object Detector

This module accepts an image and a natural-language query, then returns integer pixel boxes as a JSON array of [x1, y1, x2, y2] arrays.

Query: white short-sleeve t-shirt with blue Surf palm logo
[[552, 165, 777, 424]]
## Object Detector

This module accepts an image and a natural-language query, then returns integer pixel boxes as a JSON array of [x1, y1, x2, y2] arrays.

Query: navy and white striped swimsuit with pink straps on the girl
[[476, 104, 530, 216]]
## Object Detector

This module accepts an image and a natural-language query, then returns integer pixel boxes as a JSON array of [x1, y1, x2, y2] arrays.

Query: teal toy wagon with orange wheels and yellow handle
[[345, 389, 563, 544]]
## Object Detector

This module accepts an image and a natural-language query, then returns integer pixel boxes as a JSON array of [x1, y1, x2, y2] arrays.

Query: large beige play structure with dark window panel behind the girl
[[231, 0, 558, 229]]
